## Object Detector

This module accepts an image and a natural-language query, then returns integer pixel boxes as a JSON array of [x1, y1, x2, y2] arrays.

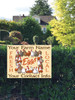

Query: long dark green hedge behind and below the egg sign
[[0, 46, 75, 100]]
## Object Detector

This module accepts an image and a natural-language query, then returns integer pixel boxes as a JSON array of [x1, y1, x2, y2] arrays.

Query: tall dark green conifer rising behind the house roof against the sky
[[30, 0, 52, 16]]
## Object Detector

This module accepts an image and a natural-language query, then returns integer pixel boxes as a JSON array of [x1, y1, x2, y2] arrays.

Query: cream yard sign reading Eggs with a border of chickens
[[7, 45, 52, 78]]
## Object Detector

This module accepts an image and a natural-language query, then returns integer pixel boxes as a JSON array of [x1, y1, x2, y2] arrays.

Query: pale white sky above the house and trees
[[0, 0, 53, 20]]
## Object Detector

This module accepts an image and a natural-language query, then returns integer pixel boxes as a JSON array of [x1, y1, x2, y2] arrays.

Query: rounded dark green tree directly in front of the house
[[21, 17, 43, 44]]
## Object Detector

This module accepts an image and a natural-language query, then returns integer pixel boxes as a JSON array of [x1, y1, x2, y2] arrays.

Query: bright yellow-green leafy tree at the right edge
[[49, 0, 75, 47]]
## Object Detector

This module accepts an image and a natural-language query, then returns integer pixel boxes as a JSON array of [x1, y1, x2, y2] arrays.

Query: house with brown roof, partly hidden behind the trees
[[13, 14, 55, 33]]
